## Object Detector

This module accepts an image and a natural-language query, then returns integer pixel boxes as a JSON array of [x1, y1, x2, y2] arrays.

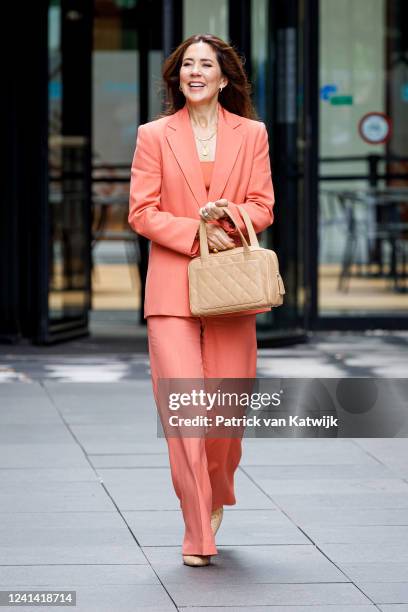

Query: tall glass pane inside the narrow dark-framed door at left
[[48, 0, 89, 332]]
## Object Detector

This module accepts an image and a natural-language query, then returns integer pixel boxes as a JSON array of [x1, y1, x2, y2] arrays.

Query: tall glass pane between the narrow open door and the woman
[[92, 0, 140, 310]]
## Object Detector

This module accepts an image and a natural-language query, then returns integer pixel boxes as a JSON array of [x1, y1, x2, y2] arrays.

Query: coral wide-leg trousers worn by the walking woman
[[147, 314, 257, 555]]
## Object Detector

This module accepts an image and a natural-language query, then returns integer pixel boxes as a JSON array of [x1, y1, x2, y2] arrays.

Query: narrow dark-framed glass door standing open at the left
[[44, 0, 92, 343]]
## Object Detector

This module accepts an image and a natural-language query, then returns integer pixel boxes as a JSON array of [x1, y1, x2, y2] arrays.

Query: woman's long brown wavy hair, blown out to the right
[[162, 34, 258, 119]]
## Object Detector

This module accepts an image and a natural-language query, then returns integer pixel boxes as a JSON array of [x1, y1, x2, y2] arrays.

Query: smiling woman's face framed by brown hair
[[180, 41, 228, 104]]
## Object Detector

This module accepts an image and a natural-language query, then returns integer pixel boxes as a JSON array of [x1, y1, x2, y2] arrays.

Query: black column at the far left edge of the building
[[0, 2, 48, 342]]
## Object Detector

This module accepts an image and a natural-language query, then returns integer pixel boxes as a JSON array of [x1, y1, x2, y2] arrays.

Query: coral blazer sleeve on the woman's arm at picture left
[[128, 124, 200, 257]]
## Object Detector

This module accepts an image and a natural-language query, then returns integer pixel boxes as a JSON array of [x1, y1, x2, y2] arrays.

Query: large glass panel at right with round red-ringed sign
[[315, 0, 408, 328]]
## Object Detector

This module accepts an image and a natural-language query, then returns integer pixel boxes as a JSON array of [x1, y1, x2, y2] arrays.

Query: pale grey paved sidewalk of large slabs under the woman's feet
[[0, 332, 408, 612]]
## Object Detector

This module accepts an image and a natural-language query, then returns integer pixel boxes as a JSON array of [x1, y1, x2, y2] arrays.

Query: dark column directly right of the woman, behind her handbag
[[269, 0, 304, 334]]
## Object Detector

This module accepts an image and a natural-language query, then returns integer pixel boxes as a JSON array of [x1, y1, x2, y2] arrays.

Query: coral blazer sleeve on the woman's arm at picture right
[[218, 122, 275, 236]]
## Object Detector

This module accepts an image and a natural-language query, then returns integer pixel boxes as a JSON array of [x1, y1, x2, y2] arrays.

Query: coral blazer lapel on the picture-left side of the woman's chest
[[166, 106, 207, 206]]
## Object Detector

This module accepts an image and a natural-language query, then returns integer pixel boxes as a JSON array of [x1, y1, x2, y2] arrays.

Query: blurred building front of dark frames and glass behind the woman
[[0, 0, 408, 345]]
